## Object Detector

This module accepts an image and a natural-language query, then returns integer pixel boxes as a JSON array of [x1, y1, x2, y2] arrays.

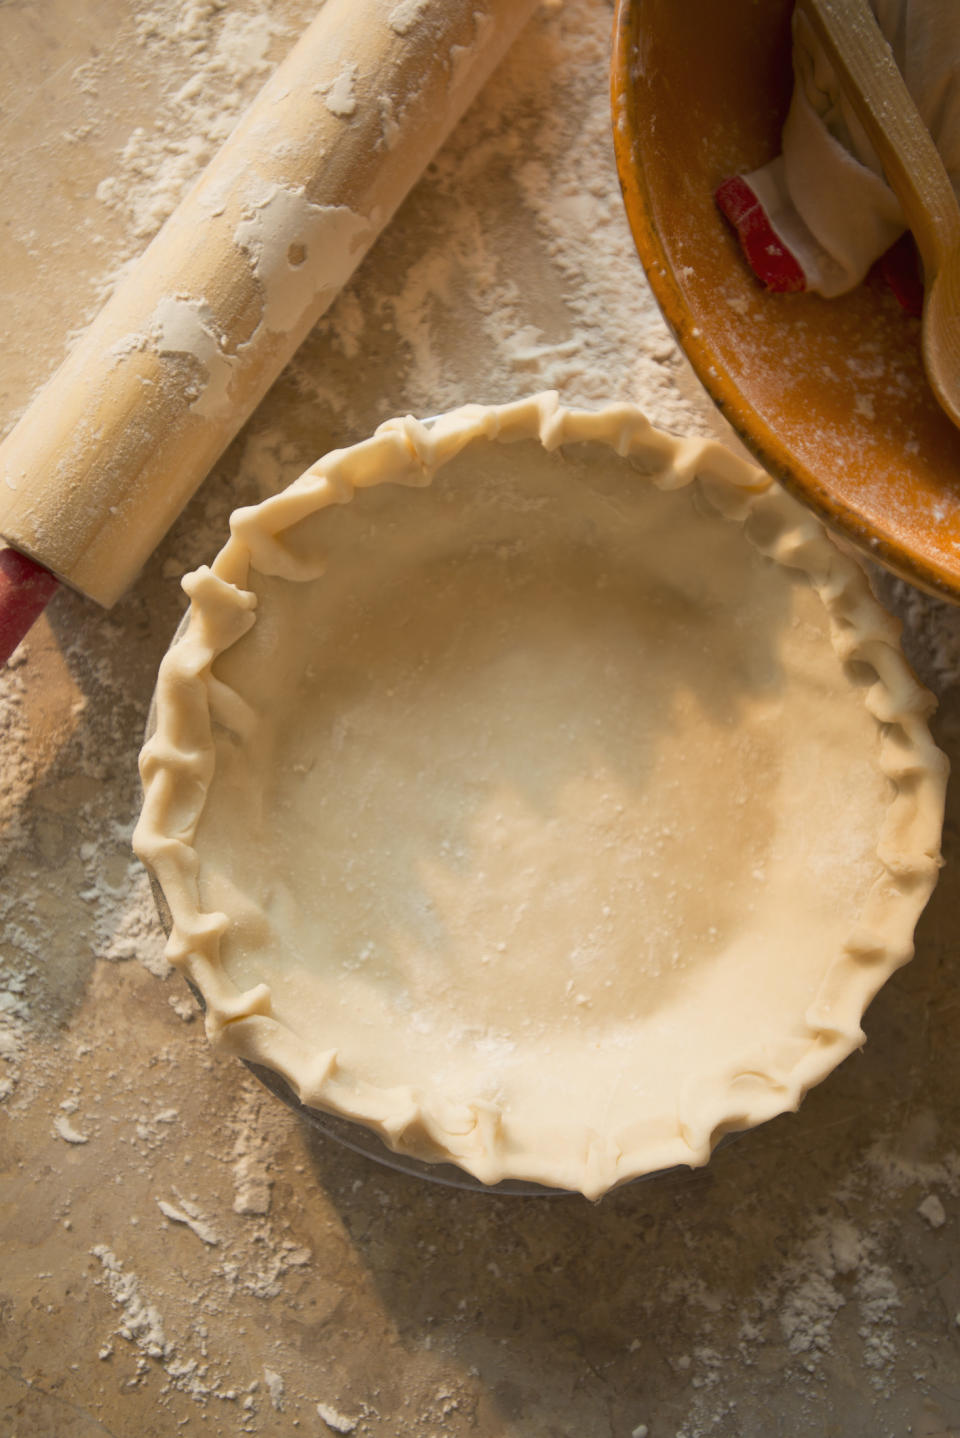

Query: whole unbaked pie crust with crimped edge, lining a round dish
[[135, 394, 946, 1196]]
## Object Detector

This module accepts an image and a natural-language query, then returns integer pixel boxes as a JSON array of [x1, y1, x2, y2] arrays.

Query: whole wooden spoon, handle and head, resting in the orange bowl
[[799, 0, 960, 427]]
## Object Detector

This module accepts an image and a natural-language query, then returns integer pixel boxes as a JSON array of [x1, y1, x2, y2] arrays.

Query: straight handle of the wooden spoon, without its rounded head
[[799, 0, 960, 276]]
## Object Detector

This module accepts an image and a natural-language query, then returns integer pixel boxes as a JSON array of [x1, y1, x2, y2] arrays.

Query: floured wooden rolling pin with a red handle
[[0, 0, 536, 663]]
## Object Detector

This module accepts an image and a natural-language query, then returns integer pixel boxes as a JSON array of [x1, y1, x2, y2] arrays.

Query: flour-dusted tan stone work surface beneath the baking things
[[0, 0, 960, 1438]]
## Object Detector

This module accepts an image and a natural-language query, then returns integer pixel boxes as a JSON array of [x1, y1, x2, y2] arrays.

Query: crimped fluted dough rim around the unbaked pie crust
[[134, 393, 947, 1198]]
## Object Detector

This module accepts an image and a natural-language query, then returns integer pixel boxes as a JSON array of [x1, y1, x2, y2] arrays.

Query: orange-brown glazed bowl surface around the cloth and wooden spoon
[[612, 0, 960, 601]]
